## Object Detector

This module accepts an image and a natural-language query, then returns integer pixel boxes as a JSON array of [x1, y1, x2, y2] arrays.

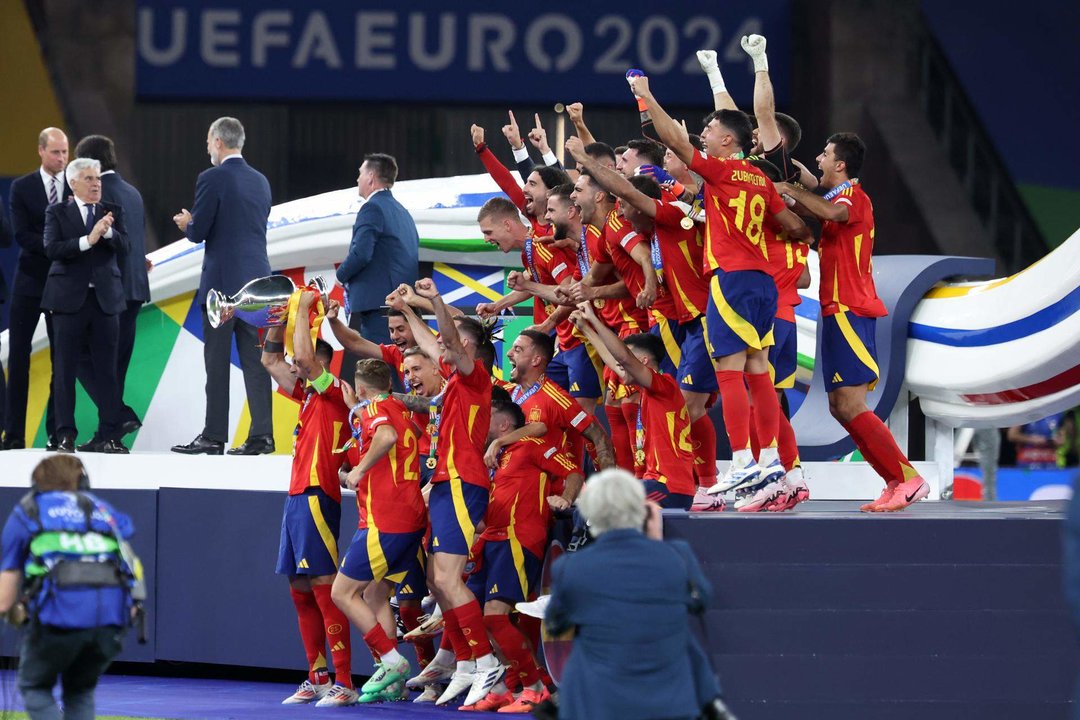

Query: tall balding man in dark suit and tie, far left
[[3, 127, 71, 450]]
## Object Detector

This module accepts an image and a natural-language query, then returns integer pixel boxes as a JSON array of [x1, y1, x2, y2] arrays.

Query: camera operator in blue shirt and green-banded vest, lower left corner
[[0, 454, 144, 720]]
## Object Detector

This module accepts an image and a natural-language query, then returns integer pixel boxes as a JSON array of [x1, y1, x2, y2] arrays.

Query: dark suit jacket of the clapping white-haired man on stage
[[41, 198, 130, 315]]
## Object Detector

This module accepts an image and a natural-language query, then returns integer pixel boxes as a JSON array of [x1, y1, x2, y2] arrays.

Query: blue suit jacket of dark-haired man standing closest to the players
[[337, 189, 420, 312]]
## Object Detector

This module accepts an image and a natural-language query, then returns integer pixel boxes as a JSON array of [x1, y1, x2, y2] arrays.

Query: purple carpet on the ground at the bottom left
[[0, 673, 528, 720]]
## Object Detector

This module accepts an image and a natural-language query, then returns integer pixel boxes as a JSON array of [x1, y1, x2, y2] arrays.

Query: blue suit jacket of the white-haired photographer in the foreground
[[545, 529, 712, 720]]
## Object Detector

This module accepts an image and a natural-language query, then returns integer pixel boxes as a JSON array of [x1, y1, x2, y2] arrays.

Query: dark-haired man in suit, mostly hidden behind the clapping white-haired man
[[75, 135, 150, 450]]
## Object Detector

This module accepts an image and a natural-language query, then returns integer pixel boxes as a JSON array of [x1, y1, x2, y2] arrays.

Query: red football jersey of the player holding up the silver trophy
[[288, 378, 349, 502]]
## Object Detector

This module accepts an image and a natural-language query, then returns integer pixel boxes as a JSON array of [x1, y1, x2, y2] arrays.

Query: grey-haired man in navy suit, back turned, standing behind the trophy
[[173, 118, 274, 454]]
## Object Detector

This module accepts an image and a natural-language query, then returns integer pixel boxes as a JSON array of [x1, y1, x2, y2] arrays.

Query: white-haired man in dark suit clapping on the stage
[[41, 158, 129, 452]]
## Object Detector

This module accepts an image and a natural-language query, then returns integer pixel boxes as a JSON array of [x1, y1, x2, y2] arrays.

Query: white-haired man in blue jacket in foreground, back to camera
[[544, 470, 734, 720]]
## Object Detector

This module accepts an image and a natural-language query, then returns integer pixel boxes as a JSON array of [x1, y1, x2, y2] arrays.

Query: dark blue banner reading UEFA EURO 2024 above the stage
[[136, 0, 791, 106]]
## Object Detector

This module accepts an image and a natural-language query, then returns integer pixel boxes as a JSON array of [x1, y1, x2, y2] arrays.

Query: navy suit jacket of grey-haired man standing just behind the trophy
[[186, 158, 270, 304]]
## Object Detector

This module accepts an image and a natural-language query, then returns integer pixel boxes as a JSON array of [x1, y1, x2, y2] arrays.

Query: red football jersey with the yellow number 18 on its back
[[690, 150, 787, 274]]
